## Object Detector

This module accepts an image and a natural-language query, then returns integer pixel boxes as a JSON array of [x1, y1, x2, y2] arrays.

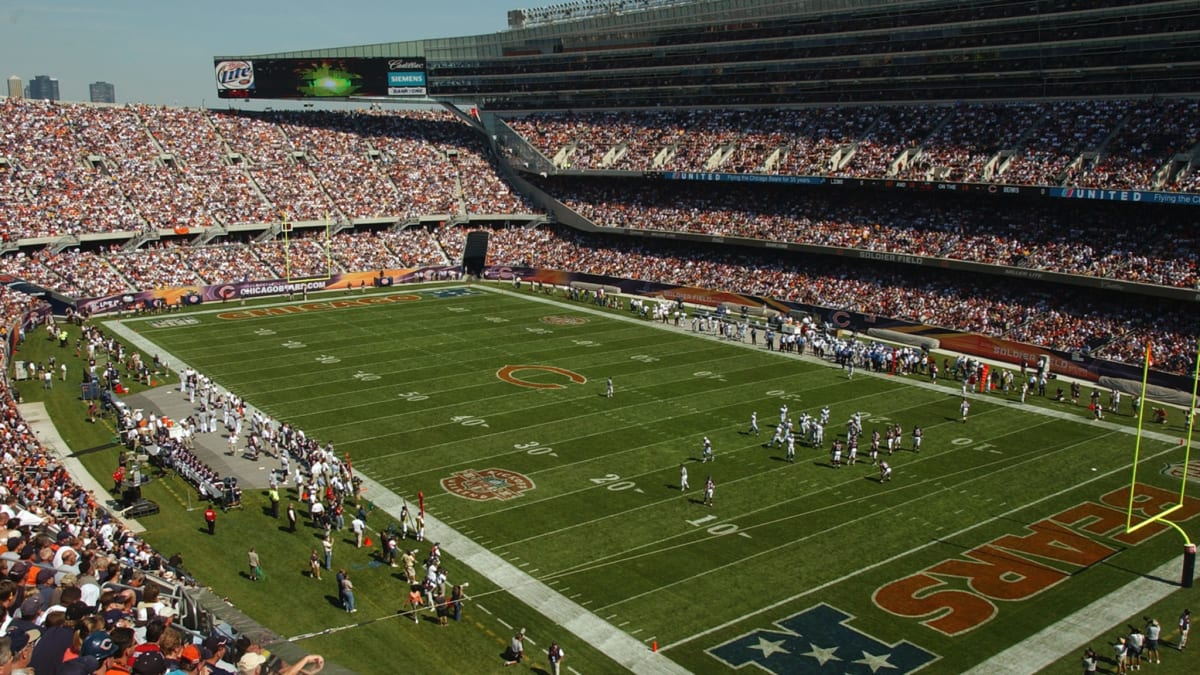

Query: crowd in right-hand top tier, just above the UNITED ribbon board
[[506, 100, 1200, 186]]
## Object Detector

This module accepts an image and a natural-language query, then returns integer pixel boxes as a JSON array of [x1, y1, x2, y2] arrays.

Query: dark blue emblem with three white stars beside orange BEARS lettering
[[706, 603, 938, 675]]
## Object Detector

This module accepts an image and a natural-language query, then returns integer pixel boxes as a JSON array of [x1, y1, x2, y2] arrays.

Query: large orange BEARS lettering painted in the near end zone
[[874, 484, 1200, 635]]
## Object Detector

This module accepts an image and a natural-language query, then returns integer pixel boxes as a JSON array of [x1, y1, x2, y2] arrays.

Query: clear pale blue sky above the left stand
[[0, 0, 511, 106]]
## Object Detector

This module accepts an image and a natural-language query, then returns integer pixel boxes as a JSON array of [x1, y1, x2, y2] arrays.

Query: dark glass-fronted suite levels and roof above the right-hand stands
[[218, 0, 1200, 110]]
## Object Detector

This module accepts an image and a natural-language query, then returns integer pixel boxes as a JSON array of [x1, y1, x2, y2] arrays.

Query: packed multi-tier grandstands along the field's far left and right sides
[[0, 98, 1200, 372]]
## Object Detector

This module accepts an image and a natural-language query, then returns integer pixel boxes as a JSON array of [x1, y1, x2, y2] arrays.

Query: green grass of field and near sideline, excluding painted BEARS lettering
[[16, 281, 1194, 673]]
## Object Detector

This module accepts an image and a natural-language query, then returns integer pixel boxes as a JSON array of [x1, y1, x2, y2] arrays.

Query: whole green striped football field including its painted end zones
[[105, 281, 1200, 674]]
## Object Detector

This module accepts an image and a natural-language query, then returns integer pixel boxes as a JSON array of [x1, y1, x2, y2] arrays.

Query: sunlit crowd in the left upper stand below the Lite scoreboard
[[0, 98, 532, 241]]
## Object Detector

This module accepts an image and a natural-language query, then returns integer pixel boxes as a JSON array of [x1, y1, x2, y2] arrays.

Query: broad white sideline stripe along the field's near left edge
[[108, 286, 689, 675]]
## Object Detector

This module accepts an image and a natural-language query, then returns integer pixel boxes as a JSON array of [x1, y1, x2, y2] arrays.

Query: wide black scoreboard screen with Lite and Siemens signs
[[212, 56, 426, 98]]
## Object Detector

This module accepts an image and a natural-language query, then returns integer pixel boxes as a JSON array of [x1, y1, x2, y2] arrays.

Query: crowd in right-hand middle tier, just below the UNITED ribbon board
[[541, 180, 1200, 288]]
